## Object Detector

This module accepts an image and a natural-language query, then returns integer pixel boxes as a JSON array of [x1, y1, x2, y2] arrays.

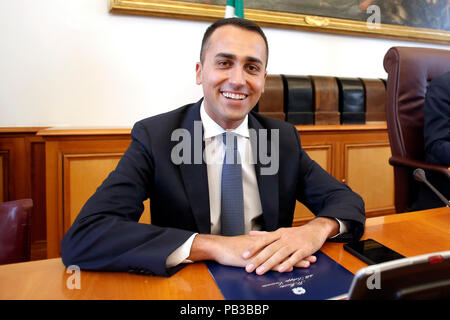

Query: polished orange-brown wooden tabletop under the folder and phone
[[0, 208, 450, 300]]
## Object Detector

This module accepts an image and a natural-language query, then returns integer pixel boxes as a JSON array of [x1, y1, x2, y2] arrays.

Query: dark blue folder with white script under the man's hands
[[207, 251, 353, 300]]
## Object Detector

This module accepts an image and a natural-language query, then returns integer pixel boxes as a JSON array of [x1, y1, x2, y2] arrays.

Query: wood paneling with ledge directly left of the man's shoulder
[[38, 129, 131, 258]]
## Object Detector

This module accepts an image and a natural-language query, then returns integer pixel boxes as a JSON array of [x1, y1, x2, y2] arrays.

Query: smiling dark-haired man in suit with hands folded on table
[[61, 18, 365, 276]]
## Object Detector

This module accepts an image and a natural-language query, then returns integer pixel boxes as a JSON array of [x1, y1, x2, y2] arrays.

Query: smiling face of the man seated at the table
[[196, 25, 267, 129]]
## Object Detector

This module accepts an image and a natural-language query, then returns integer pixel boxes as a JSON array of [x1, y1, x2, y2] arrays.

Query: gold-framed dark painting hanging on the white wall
[[110, 0, 450, 44]]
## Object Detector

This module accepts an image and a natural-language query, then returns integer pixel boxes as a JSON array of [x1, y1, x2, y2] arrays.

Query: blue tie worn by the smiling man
[[221, 133, 245, 236]]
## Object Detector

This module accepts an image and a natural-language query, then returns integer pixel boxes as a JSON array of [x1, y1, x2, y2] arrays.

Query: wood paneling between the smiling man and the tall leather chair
[[294, 123, 395, 225]]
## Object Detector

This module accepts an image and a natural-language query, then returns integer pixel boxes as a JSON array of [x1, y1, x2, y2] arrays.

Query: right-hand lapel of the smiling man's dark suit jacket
[[248, 113, 279, 231]]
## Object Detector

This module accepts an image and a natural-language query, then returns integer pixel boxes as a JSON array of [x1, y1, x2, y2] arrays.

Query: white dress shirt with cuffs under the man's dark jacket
[[166, 103, 347, 268]]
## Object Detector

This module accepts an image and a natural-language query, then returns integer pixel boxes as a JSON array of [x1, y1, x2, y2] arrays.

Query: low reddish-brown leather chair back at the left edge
[[0, 199, 33, 264]]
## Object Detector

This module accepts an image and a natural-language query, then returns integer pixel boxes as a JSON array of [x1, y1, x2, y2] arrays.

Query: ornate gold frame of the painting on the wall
[[110, 0, 450, 44]]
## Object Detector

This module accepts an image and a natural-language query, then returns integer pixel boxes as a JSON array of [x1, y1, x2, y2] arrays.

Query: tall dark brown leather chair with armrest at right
[[384, 47, 450, 213]]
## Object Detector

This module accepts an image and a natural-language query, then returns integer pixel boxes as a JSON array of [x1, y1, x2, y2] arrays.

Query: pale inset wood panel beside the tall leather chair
[[344, 143, 394, 216]]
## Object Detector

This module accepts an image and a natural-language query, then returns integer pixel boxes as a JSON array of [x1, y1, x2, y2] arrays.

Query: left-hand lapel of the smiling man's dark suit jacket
[[180, 100, 211, 234]]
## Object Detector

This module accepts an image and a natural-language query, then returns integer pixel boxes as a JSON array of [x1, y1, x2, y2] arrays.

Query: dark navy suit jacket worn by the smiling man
[[61, 100, 365, 276]]
